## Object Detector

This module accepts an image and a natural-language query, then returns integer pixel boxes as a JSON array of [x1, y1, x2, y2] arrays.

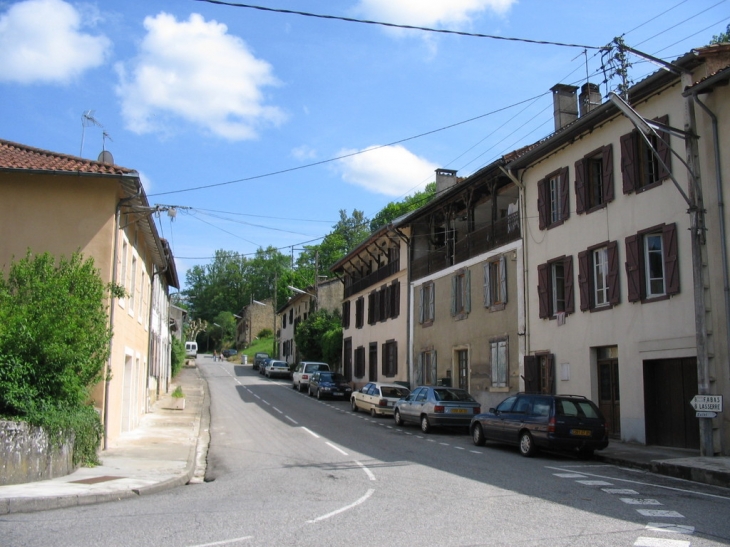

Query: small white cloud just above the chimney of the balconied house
[[337, 145, 438, 197]]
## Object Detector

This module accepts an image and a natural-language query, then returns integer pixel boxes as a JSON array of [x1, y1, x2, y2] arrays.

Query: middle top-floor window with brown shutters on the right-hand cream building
[[575, 145, 613, 214]]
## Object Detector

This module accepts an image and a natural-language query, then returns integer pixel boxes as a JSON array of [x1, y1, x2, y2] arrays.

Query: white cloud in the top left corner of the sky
[[0, 0, 111, 84]]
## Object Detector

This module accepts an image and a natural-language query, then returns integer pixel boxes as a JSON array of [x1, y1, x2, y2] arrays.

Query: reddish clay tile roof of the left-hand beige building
[[0, 139, 137, 175]]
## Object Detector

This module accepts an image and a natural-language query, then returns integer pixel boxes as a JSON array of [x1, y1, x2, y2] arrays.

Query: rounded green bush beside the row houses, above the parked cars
[[294, 310, 342, 362]]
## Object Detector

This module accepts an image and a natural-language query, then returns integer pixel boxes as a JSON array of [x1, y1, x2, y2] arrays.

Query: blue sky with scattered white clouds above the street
[[0, 0, 730, 288]]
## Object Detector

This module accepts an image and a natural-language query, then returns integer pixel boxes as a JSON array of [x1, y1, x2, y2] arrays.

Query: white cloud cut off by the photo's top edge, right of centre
[[357, 0, 517, 27]]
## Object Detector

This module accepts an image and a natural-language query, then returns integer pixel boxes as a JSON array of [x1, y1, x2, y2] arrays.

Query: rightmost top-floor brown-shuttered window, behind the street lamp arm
[[621, 116, 671, 194]]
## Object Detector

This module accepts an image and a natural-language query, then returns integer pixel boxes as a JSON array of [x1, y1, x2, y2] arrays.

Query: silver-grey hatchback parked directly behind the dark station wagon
[[393, 386, 482, 433]]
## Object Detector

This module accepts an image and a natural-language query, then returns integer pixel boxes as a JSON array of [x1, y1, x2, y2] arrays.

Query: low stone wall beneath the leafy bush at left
[[0, 420, 76, 486]]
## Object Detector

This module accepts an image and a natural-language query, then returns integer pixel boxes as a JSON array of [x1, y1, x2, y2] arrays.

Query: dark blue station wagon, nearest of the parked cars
[[470, 393, 608, 458]]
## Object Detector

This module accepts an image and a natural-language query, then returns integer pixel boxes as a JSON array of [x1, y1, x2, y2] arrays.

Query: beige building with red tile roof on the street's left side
[[0, 140, 176, 447]]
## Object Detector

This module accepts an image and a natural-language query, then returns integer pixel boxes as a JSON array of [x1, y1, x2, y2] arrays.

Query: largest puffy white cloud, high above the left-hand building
[[117, 13, 285, 140]]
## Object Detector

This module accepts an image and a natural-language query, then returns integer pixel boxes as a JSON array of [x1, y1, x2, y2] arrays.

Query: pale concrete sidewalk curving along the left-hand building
[[0, 367, 210, 514]]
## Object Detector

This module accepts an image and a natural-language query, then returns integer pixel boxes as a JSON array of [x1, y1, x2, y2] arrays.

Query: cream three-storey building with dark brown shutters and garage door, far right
[[507, 47, 730, 454]]
